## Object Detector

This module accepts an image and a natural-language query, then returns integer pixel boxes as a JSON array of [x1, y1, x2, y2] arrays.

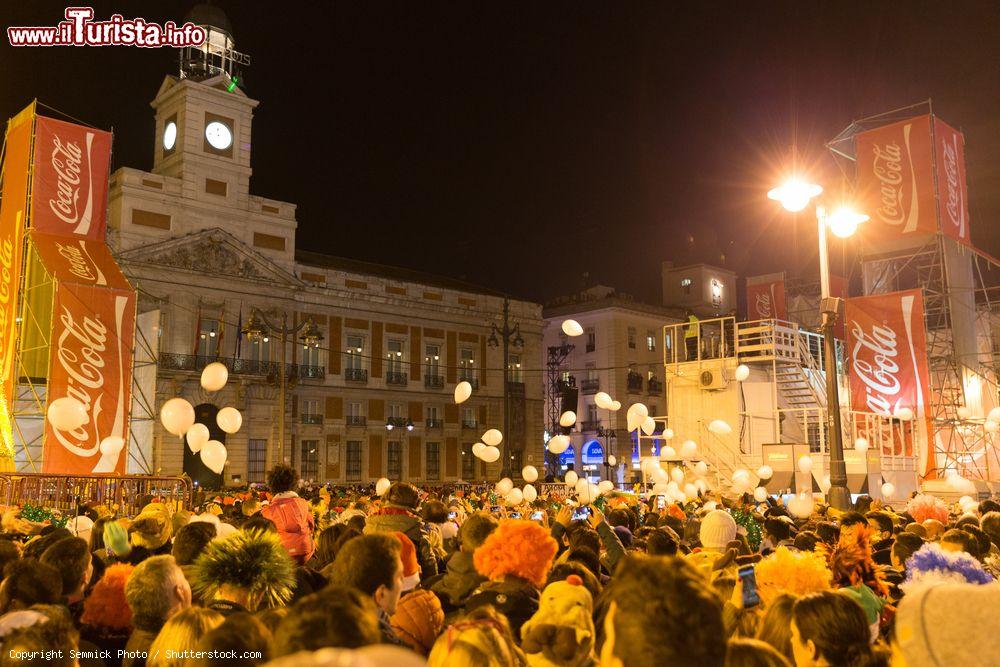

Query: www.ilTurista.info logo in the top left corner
[[7, 7, 207, 49]]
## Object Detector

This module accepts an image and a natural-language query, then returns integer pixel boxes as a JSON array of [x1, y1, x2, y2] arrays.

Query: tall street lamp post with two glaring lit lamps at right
[[767, 180, 868, 510]]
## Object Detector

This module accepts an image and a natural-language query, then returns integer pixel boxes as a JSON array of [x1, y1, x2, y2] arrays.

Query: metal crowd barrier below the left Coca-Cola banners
[[0, 473, 193, 516]]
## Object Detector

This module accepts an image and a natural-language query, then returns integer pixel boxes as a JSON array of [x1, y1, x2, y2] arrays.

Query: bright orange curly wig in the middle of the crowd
[[472, 519, 559, 588]]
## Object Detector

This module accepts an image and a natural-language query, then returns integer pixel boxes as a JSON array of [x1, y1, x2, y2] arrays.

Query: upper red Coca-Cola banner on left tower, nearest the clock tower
[[31, 116, 111, 241]]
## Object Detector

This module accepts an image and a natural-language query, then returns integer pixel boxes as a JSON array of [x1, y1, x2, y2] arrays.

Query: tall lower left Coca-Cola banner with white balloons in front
[[42, 282, 136, 475]]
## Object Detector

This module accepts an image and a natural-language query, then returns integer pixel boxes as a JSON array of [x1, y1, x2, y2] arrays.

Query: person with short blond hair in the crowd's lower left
[[122, 556, 191, 667]]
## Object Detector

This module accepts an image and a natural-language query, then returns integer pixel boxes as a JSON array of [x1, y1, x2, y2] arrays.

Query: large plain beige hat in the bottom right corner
[[896, 584, 1000, 667]]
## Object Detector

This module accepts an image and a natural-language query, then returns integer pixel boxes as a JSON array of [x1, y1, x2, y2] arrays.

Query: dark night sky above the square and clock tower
[[0, 0, 1000, 301]]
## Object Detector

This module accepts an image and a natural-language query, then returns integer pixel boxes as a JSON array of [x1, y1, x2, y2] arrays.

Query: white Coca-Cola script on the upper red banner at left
[[49, 132, 94, 234]]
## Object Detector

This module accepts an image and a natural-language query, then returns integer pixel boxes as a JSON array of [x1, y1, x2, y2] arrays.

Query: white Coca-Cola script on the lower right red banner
[[851, 320, 902, 416]]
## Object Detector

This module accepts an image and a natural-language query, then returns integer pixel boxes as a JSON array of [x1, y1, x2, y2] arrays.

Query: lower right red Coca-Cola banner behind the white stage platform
[[845, 289, 930, 455]]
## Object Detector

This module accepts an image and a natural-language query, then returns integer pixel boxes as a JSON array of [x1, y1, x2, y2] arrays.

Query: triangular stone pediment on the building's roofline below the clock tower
[[118, 227, 304, 287]]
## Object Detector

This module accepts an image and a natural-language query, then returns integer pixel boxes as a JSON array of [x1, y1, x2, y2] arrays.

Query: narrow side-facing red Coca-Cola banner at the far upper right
[[934, 118, 972, 246]]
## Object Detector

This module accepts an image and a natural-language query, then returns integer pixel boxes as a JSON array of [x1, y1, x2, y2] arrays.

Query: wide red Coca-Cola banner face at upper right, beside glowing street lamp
[[855, 115, 937, 242]]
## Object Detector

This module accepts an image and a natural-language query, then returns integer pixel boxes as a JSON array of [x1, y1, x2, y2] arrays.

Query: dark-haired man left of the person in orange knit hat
[[323, 534, 405, 646]]
